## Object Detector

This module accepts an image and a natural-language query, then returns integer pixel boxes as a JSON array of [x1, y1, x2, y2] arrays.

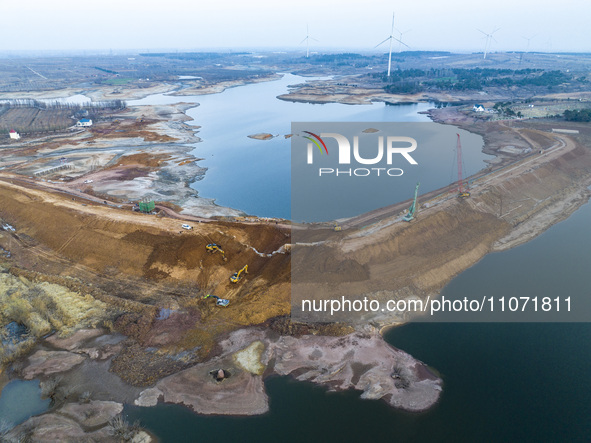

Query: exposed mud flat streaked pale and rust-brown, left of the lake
[[0, 99, 244, 217]]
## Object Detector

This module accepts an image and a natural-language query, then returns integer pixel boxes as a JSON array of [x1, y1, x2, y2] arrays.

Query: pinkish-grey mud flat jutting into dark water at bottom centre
[[135, 329, 442, 415]]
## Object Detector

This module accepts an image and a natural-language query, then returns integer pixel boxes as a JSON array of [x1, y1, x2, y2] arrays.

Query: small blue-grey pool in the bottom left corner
[[0, 380, 50, 426]]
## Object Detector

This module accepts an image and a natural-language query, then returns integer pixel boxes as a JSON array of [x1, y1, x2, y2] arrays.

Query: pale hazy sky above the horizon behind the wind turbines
[[0, 0, 591, 52]]
